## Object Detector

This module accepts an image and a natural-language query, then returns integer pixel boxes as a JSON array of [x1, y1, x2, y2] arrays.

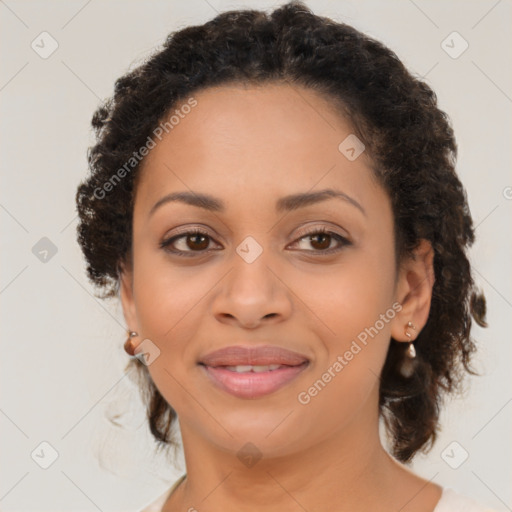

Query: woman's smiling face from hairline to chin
[[121, 85, 424, 456]]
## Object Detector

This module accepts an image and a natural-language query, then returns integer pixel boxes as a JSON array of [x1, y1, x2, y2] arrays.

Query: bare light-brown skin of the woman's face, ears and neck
[[121, 84, 441, 512]]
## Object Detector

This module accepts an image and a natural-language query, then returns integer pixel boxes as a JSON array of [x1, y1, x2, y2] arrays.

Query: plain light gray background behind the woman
[[0, 0, 512, 511]]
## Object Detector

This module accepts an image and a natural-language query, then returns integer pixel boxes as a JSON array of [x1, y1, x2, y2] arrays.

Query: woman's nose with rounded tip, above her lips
[[212, 254, 293, 329]]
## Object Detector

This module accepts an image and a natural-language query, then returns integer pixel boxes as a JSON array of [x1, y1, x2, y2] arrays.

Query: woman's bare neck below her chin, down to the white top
[[164, 390, 441, 512]]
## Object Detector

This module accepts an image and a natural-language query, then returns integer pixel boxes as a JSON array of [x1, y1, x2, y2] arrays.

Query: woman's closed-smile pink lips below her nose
[[200, 345, 309, 398]]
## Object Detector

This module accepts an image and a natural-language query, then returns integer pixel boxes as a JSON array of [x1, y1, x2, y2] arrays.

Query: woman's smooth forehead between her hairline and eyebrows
[[137, 84, 382, 218]]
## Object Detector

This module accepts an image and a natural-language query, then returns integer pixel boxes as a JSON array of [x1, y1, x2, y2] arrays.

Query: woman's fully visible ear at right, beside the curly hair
[[391, 239, 435, 342]]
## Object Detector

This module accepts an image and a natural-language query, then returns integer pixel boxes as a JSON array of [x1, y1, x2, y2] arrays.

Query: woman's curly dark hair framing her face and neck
[[76, 1, 487, 463]]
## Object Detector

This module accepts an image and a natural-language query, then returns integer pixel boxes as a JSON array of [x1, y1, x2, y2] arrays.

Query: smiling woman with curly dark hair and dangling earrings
[[77, 2, 488, 512]]
